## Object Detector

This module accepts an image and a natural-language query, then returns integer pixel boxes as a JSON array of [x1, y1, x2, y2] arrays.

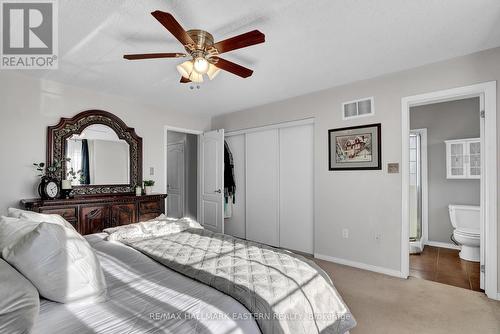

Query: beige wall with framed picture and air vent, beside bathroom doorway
[[212, 48, 500, 288]]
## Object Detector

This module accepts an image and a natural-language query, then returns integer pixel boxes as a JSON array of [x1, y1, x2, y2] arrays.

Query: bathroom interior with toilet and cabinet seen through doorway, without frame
[[409, 97, 481, 291]]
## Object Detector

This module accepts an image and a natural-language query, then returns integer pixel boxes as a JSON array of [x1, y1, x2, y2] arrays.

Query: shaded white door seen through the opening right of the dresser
[[167, 143, 185, 218]]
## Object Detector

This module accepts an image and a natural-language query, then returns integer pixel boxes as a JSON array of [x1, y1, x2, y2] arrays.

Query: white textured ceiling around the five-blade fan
[[17, 0, 500, 115]]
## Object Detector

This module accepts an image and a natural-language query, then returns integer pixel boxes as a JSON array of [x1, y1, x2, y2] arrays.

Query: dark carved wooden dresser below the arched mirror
[[21, 194, 167, 234]]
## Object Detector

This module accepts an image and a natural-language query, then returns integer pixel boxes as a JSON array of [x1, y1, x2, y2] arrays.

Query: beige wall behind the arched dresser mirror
[[0, 71, 210, 214]]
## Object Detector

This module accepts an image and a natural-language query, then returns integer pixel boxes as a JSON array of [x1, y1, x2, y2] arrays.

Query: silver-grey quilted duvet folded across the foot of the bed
[[107, 224, 356, 334]]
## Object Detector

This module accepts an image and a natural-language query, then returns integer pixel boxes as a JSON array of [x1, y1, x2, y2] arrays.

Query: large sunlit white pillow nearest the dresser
[[2, 223, 106, 303]]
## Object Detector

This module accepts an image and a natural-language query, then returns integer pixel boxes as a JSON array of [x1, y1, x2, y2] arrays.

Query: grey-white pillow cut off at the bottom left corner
[[0, 259, 40, 334]]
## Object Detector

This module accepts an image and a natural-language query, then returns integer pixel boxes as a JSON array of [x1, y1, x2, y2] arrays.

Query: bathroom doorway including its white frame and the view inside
[[401, 82, 498, 299]]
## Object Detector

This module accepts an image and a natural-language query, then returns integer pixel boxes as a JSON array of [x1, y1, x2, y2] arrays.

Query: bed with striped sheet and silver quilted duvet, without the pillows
[[33, 221, 356, 334]]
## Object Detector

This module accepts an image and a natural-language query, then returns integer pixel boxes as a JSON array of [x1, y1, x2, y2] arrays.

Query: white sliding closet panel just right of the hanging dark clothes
[[245, 129, 279, 246]]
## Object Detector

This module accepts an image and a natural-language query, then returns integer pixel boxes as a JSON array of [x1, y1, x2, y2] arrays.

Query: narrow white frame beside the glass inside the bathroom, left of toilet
[[410, 128, 429, 246]]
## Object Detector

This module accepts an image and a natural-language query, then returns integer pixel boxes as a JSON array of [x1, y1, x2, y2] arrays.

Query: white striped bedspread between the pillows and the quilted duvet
[[33, 233, 260, 334]]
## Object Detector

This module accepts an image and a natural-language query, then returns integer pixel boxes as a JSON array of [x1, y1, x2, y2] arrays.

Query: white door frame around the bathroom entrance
[[401, 81, 500, 299]]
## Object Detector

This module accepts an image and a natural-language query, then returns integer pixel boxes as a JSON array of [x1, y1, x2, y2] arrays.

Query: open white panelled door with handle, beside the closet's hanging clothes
[[198, 130, 224, 233]]
